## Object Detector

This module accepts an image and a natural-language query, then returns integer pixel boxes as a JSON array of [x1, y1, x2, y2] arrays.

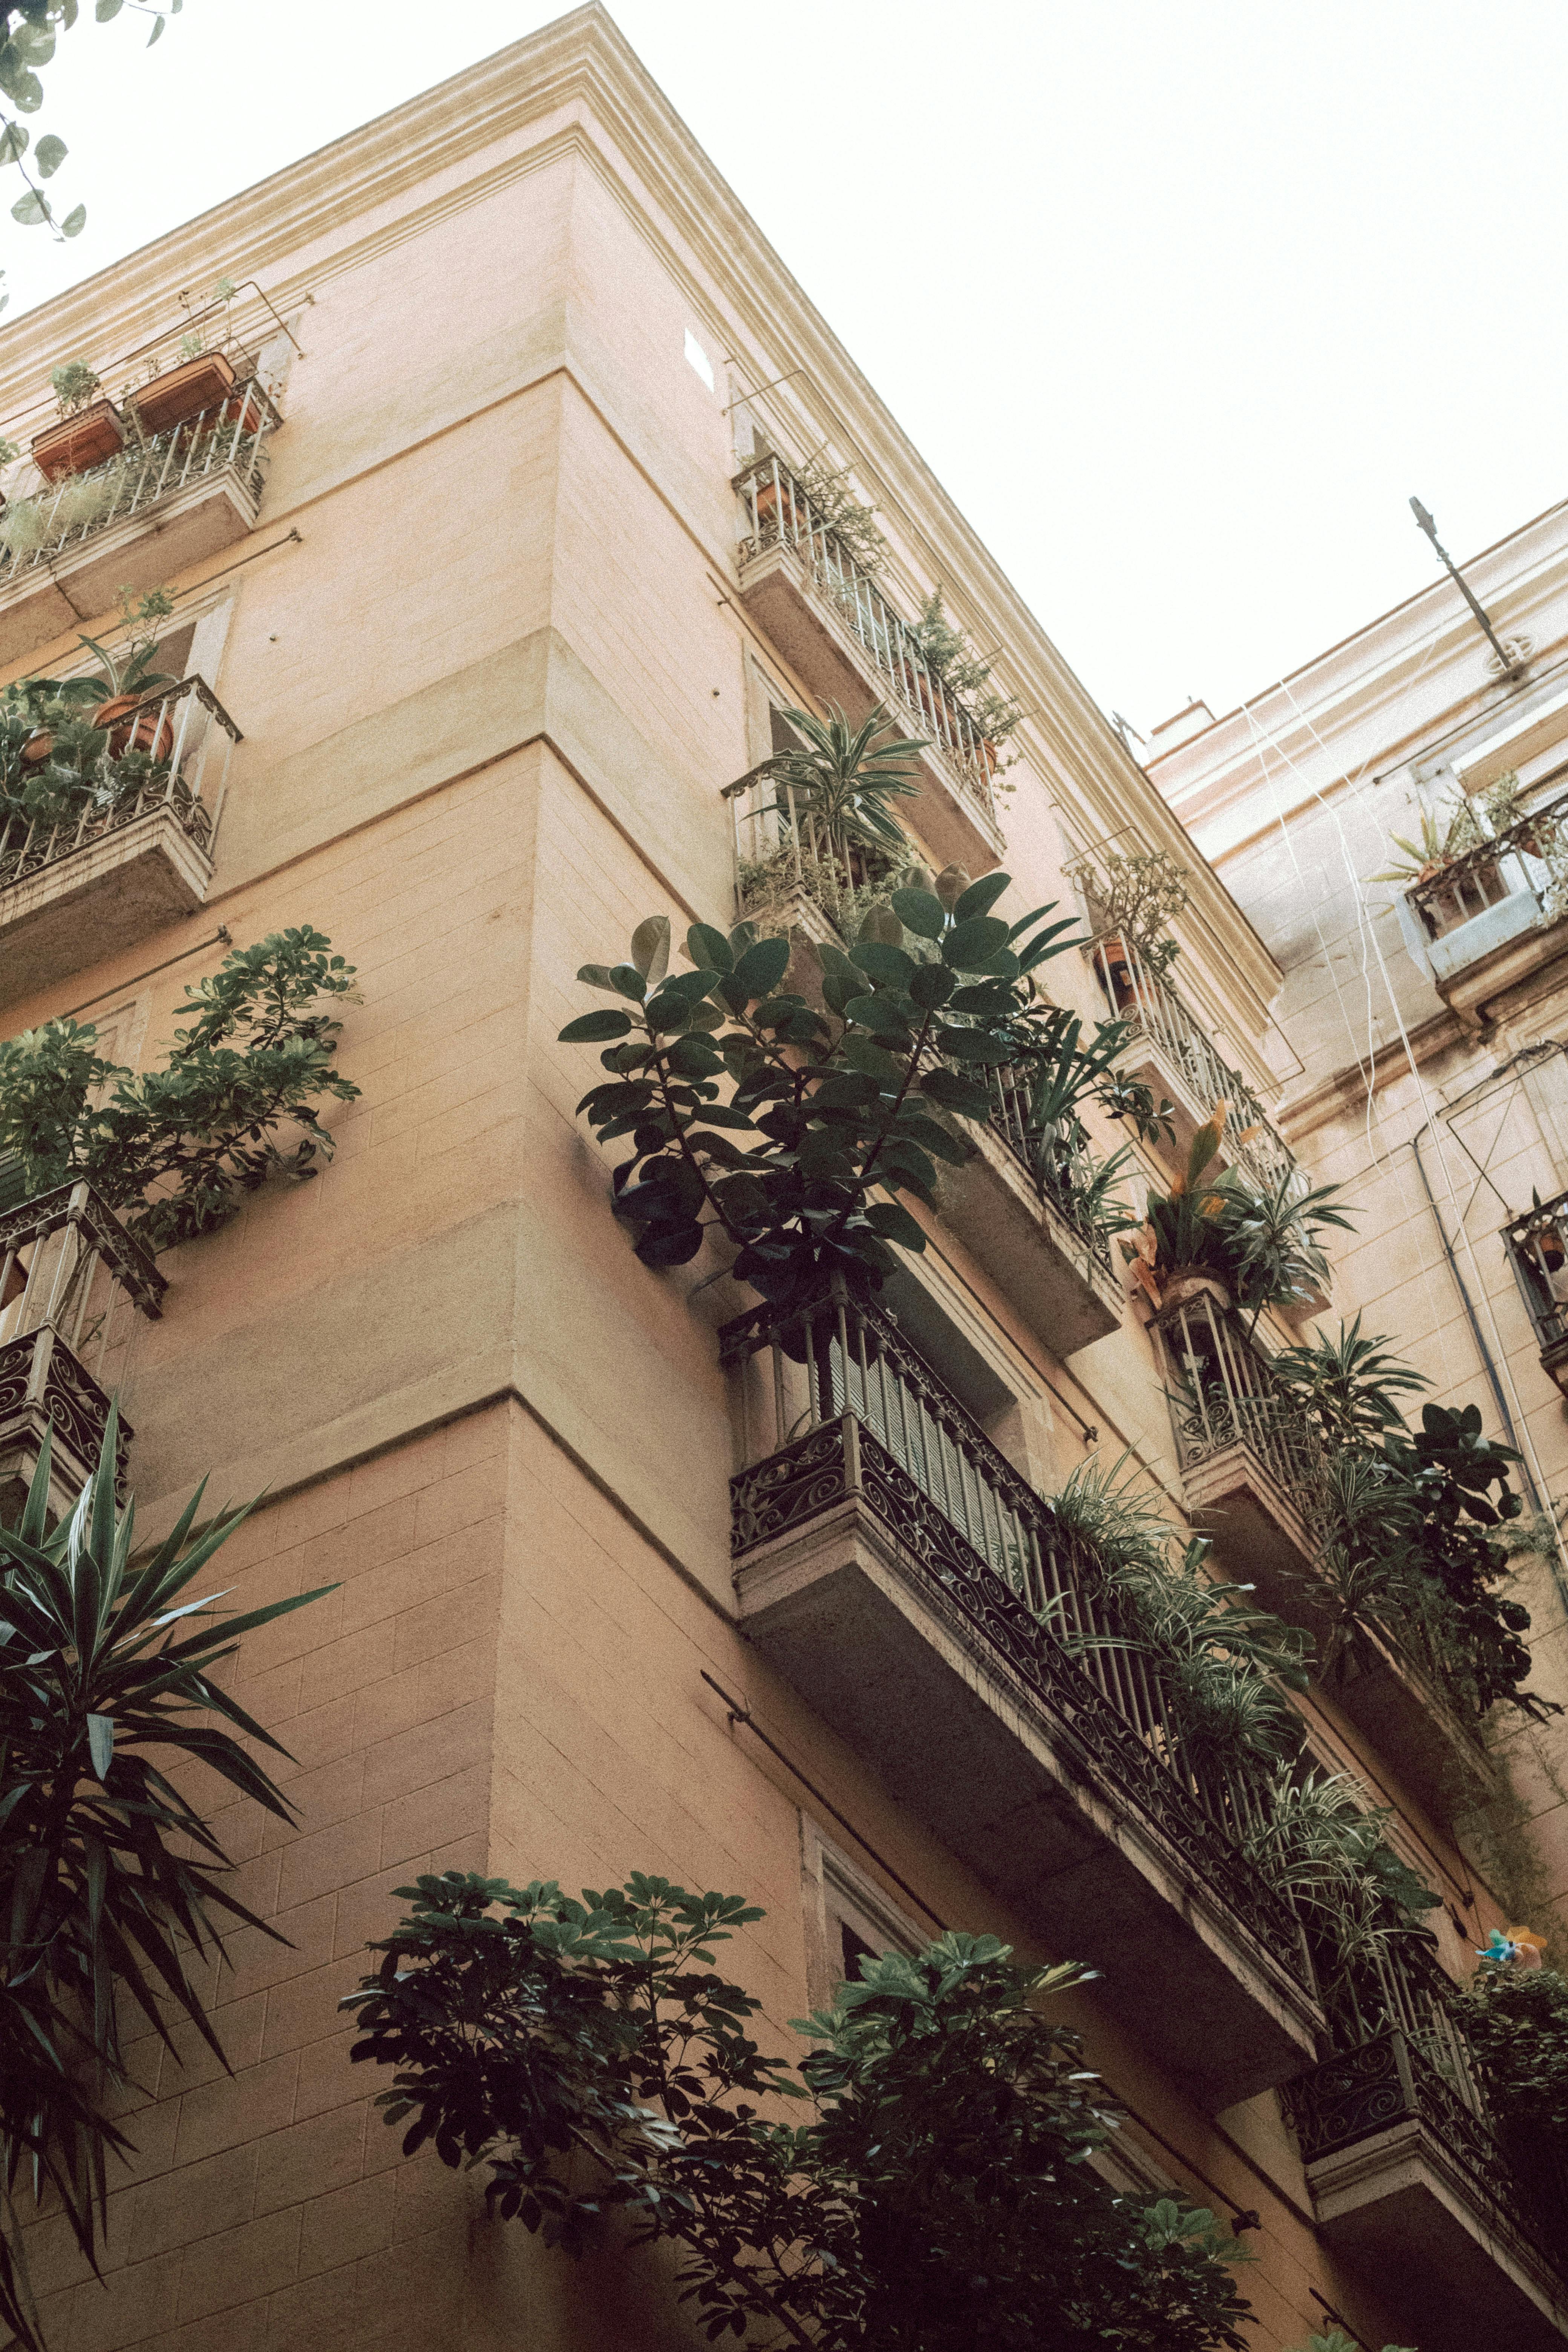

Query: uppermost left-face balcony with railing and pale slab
[[0, 376, 282, 666]]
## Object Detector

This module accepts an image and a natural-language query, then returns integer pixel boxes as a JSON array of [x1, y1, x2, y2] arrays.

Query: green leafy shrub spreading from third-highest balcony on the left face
[[0, 929, 360, 1249]]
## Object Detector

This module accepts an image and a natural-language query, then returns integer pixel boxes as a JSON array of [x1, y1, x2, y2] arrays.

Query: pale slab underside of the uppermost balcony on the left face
[[0, 466, 256, 666]]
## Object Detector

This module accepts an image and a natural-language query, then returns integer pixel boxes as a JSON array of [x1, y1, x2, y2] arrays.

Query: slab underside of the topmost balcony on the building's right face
[[741, 546, 1001, 877]]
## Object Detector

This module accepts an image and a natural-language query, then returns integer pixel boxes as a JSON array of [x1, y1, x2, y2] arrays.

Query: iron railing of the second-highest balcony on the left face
[[0, 677, 240, 891]]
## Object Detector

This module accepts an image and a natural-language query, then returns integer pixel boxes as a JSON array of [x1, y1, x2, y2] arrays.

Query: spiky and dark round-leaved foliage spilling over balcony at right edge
[[1272, 1317, 1561, 1719]]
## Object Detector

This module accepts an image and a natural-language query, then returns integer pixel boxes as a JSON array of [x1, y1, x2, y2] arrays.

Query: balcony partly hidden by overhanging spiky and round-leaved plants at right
[[1154, 1294, 1498, 1811]]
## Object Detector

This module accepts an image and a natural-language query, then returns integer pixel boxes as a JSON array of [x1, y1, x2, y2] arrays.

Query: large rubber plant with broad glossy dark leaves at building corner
[[559, 873, 1074, 1315]]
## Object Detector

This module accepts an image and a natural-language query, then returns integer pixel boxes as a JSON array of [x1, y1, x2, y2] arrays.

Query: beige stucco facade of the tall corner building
[[0, 7, 1568, 2352]]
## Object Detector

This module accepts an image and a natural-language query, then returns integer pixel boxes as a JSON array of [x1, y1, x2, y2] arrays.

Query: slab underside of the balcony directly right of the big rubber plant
[[940, 1129, 1121, 1357]]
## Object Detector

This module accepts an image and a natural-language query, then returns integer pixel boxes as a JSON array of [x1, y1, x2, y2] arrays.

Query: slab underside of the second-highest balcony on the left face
[[0, 807, 211, 1004]]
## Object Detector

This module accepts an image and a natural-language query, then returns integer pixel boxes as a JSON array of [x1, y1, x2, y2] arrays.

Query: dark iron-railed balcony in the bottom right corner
[[1283, 1966, 1568, 2352]]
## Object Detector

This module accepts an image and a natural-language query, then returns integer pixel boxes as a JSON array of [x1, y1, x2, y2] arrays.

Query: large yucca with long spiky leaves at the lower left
[[0, 1411, 331, 2347]]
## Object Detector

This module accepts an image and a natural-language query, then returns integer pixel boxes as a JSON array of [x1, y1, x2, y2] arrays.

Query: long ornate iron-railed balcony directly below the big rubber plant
[[724, 1301, 1321, 2107]]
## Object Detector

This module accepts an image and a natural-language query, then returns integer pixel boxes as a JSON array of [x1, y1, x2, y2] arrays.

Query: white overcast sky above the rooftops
[[0, 0, 1568, 729]]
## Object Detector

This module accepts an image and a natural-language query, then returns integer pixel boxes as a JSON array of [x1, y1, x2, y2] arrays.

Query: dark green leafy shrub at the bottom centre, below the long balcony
[[343, 1870, 1248, 2352]]
